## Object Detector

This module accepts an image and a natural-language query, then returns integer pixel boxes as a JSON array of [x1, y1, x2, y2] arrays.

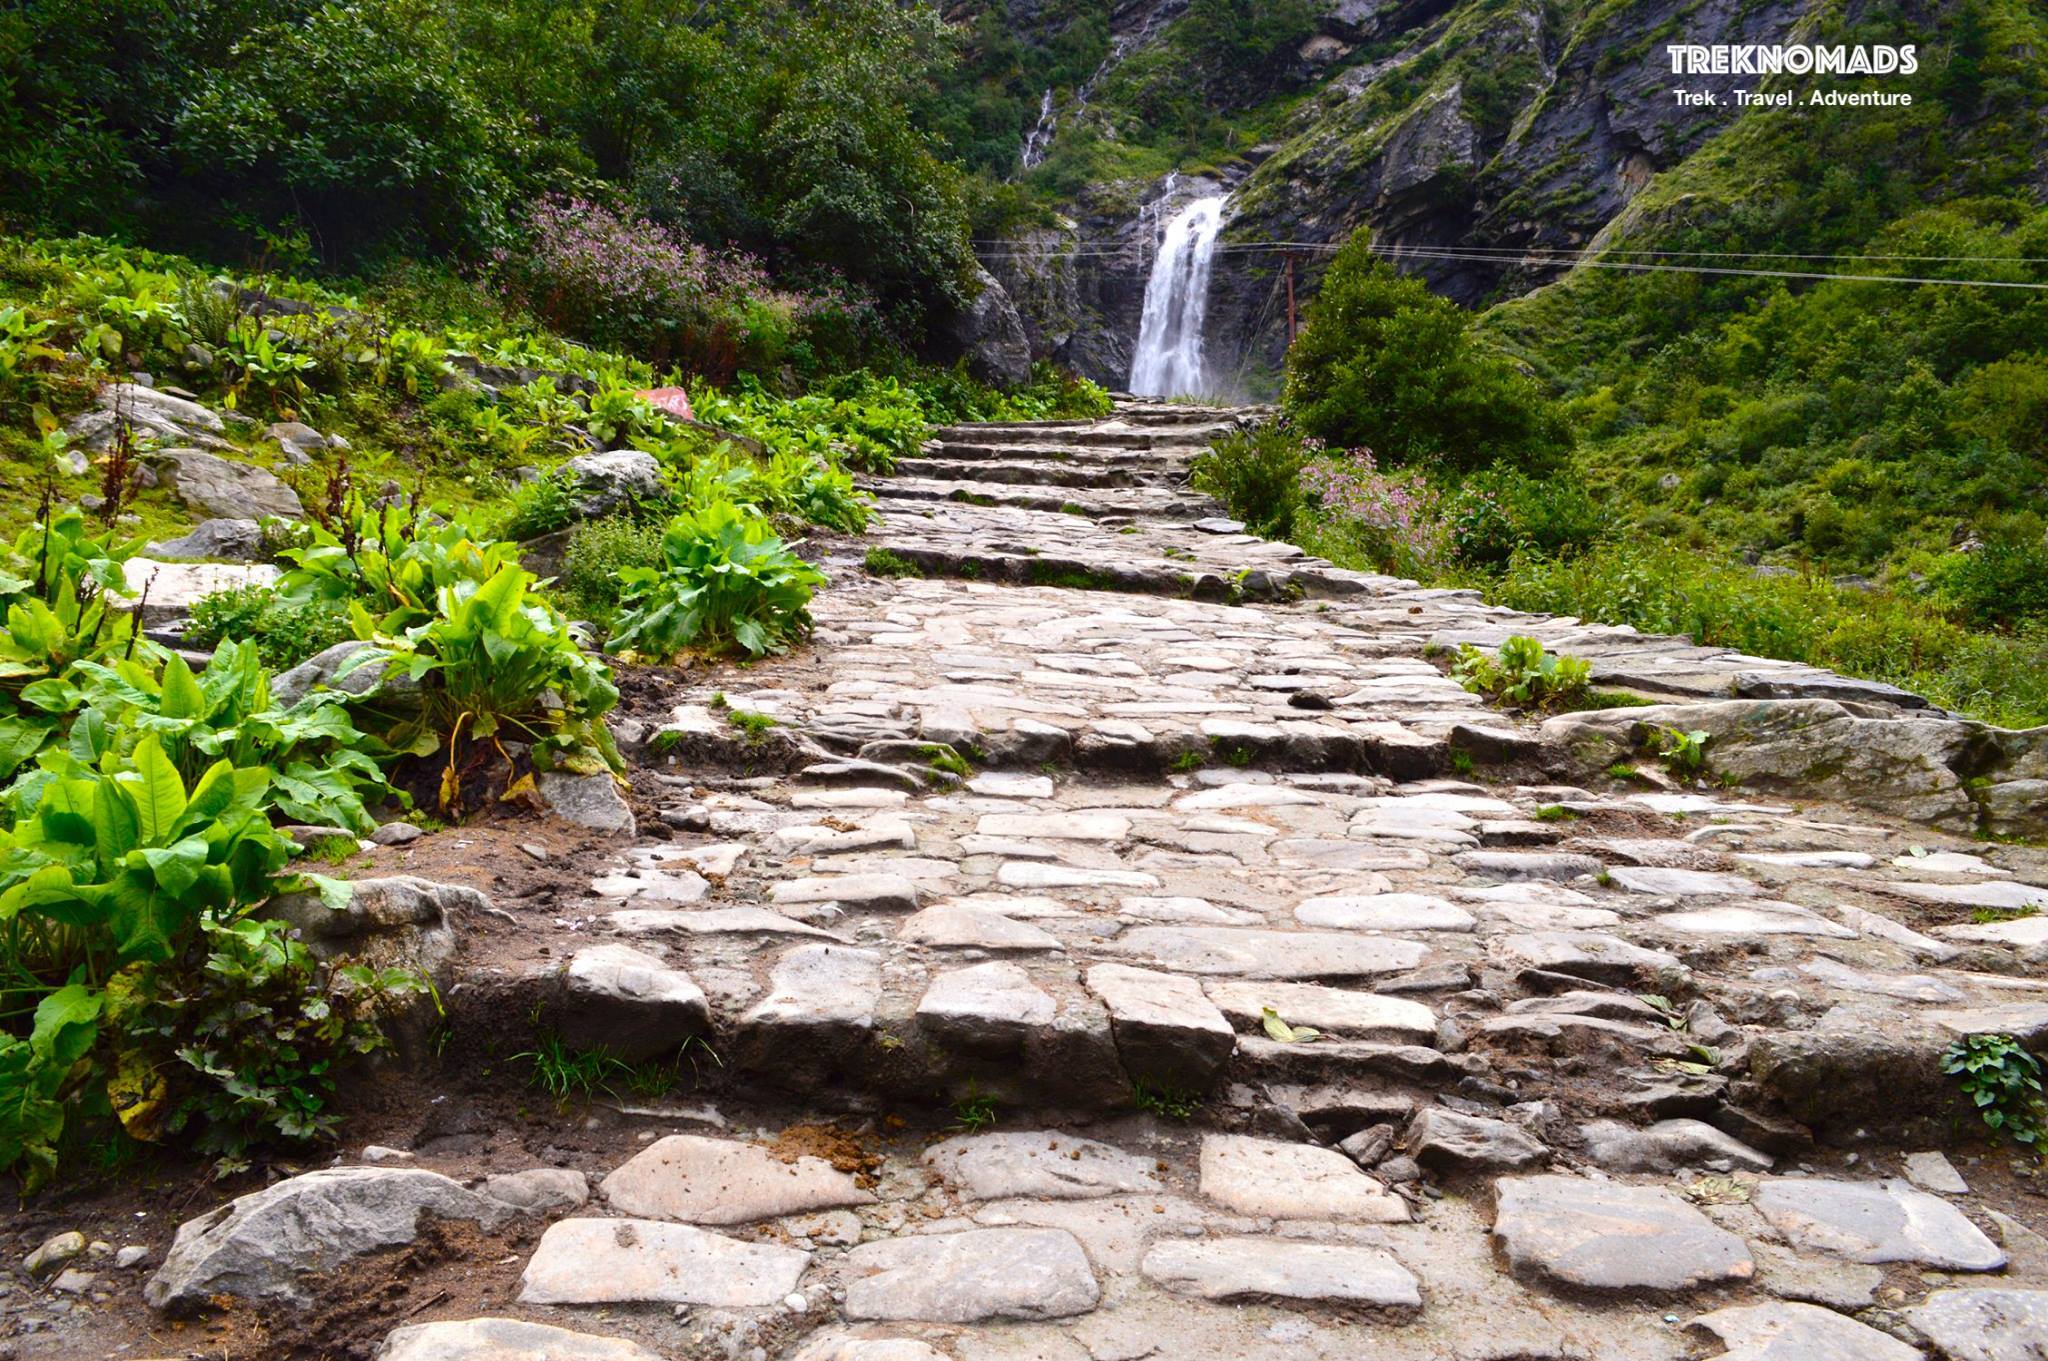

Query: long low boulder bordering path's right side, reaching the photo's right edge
[[1542, 700, 2048, 835]]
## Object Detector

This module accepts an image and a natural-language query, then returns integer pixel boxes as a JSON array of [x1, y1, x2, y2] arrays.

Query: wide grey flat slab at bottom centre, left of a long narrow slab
[[846, 1228, 1102, 1324]]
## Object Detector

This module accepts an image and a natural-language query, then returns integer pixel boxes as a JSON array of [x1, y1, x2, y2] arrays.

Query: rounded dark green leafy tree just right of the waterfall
[[1284, 229, 1571, 471]]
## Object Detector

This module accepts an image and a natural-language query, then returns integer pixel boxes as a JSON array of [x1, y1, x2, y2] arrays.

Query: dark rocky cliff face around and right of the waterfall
[[989, 0, 1884, 395]]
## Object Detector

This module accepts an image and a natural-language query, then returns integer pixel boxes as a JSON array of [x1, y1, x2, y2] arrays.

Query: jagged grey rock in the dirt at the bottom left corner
[[143, 1167, 516, 1310]]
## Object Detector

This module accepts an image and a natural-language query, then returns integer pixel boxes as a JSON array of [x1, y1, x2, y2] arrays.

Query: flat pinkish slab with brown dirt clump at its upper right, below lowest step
[[598, 1134, 874, 1224]]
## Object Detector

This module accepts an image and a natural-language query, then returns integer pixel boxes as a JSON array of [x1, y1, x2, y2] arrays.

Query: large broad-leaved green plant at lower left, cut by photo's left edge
[[0, 735, 424, 1187]]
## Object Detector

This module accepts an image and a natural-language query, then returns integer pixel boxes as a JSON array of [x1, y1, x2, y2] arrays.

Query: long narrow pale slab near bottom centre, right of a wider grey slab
[[1141, 1238, 1421, 1312]]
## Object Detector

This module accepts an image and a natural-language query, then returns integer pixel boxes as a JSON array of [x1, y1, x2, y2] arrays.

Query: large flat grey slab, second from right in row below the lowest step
[[1493, 1177, 1757, 1293]]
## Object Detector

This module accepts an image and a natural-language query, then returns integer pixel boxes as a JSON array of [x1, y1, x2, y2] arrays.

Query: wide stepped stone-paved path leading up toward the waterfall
[[136, 405, 2048, 1361]]
